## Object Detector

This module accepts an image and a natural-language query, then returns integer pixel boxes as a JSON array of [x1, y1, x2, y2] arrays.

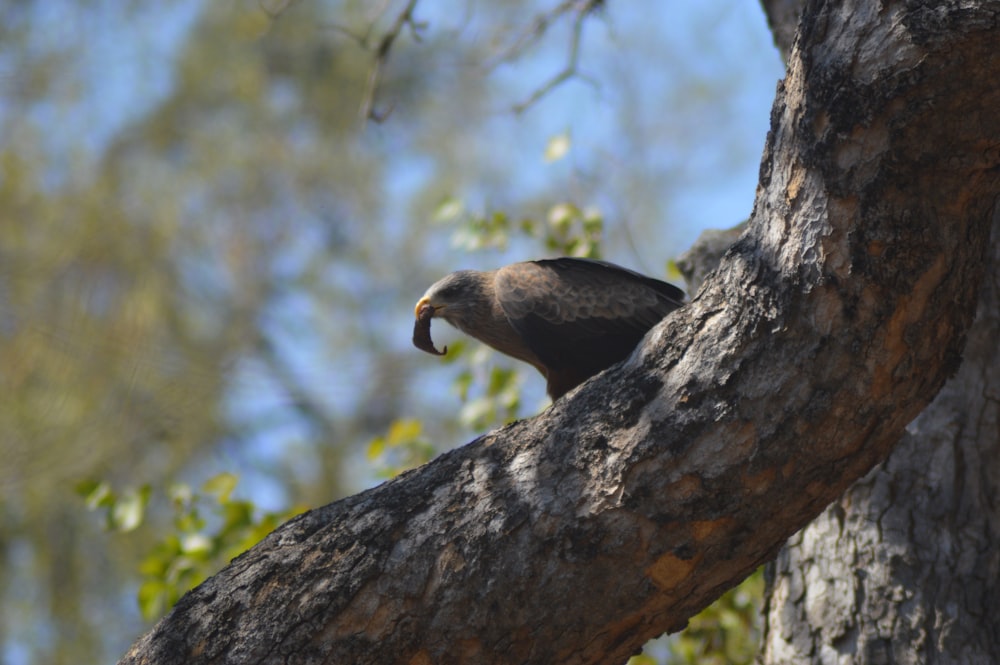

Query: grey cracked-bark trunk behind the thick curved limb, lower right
[[763, 226, 1000, 665]]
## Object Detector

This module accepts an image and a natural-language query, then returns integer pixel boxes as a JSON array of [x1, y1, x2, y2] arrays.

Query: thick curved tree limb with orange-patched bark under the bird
[[122, 0, 1000, 663]]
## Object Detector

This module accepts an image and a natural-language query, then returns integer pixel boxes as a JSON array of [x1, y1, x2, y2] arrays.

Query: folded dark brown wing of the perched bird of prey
[[495, 258, 684, 387]]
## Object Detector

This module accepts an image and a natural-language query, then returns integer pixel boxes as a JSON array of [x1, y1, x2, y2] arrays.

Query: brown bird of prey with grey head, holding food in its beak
[[413, 257, 684, 400]]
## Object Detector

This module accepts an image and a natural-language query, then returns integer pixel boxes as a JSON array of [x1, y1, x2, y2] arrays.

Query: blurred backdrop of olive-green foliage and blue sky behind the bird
[[0, 0, 780, 664]]
